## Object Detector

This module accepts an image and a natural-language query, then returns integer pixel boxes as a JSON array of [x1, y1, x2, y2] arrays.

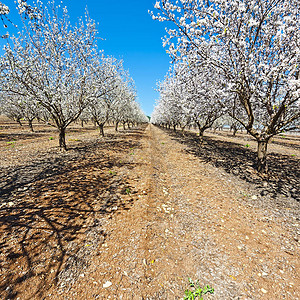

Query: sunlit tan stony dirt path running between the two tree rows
[[50, 125, 300, 300]]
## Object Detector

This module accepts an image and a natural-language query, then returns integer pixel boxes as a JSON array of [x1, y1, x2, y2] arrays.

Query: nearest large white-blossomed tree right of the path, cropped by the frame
[[152, 0, 300, 172]]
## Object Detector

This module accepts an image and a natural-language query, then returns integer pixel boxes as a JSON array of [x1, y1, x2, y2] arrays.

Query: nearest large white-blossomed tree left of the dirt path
[[2, 3, 96, 149]]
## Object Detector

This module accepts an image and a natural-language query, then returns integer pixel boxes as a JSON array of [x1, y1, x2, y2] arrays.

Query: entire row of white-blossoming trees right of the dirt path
[[150, 0, 300, 172]]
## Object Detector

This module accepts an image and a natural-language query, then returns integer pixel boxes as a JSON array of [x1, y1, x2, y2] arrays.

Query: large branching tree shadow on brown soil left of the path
[[0, 126, 145, 299]]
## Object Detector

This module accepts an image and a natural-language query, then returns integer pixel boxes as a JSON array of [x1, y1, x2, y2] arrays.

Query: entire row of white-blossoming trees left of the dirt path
[[0, 2, 148, 149]]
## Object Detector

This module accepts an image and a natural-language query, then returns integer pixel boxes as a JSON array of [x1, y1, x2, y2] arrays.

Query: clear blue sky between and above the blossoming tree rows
[[1, 0, 170, 115]]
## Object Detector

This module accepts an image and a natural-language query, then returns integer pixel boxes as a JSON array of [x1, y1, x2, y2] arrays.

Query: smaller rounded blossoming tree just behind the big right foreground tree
[[154, 59, 224, 143]]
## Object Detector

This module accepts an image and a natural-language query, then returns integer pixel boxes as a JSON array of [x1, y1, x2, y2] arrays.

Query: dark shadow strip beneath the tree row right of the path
[[164, 129, 300, 201]]
